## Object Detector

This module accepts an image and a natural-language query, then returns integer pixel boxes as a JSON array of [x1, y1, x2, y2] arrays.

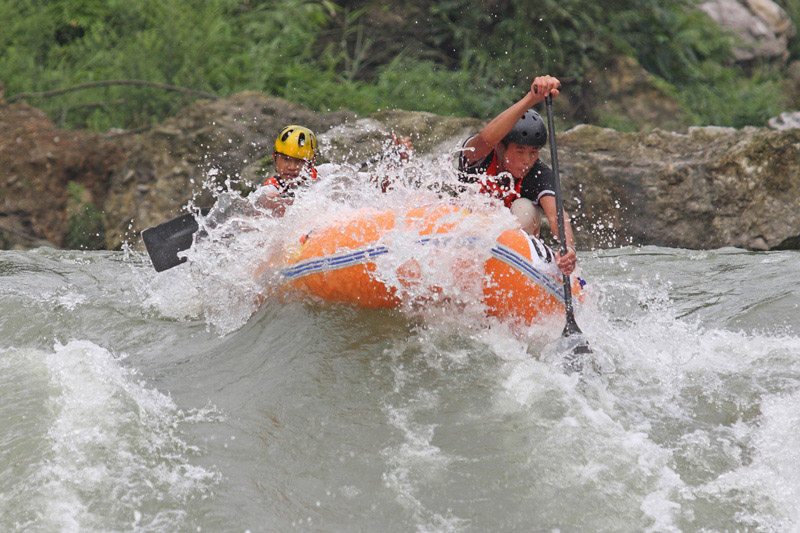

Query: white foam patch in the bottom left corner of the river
[[0, 340, 219, 531]]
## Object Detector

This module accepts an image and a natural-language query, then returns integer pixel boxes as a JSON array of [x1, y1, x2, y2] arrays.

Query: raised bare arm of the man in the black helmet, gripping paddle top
[[464, 76, 561, 163]]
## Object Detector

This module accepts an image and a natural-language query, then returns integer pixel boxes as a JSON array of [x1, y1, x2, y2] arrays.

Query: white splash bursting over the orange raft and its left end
[[146, 154, 536, 334]]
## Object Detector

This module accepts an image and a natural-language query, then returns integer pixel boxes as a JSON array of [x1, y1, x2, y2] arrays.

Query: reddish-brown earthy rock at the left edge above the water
[[0, 98, 123, 248]]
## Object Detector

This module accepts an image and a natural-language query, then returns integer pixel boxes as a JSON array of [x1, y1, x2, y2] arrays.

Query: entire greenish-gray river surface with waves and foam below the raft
[[0, 166, 800, 532]]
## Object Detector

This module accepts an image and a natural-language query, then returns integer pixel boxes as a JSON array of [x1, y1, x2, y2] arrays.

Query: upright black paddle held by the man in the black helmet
[[544, 95, 592, 362]]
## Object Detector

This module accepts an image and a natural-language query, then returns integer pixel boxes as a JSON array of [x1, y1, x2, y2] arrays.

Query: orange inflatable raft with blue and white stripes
[[281, 204, 582, 324]]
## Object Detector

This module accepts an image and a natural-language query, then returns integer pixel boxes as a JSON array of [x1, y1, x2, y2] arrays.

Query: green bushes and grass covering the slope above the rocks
[[0, 0, 800, 131]]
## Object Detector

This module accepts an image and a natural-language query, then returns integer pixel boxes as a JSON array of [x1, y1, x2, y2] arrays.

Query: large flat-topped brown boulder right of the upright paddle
[[559, 126, 800, 250]]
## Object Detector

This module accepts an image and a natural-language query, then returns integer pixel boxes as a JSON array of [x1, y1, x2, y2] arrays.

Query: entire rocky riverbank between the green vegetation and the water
[[0, 86, 800, 250]]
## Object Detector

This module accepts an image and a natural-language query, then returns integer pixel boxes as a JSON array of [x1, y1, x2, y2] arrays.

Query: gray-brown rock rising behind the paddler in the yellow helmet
[[104, 100, 481, 249]]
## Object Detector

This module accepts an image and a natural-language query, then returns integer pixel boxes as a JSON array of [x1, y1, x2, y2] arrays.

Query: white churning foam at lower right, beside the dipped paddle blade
[[507, 255, 800, 531]]
